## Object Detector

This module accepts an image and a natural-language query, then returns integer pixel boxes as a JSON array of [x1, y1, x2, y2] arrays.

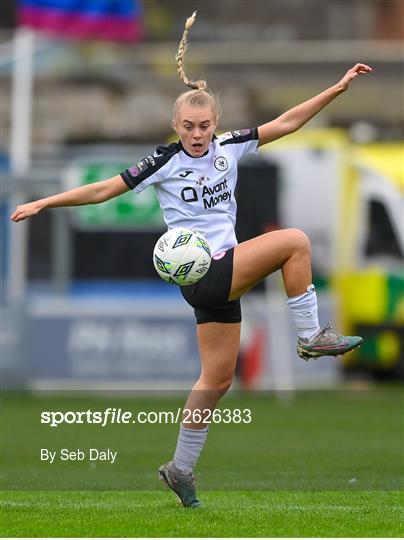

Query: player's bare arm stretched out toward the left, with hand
[[10, 175, 129, 222]]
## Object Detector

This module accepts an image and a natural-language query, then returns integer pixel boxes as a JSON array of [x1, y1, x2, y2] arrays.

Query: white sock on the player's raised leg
[[286, 285, 320, 339]]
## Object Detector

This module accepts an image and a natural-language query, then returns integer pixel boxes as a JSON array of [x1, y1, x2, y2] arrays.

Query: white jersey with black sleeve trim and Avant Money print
[[121, 128, 258, 255]]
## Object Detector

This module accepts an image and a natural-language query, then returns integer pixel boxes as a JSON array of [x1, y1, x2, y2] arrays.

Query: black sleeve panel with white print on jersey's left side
[[121, 143, 182, 189]]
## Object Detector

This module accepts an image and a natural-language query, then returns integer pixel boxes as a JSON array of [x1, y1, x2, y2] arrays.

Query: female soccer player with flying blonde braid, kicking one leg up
[[11, 13, 372, 507]]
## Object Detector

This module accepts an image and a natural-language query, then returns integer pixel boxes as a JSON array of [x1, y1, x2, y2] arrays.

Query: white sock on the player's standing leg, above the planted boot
[[174, 425, 209, 474]]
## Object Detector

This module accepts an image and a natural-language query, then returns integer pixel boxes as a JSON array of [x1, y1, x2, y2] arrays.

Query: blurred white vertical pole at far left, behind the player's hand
[[8, 27, 34, 303]]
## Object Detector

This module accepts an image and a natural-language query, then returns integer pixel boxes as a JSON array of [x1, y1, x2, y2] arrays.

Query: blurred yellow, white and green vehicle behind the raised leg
[[263, 129, 404, 378]]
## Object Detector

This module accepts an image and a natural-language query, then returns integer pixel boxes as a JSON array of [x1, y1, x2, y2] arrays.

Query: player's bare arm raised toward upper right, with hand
[[258, 64, 372, 146]]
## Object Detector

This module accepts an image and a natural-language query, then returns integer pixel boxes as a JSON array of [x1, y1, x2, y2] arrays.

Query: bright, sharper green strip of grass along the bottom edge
[[1, 491, 404, 537]]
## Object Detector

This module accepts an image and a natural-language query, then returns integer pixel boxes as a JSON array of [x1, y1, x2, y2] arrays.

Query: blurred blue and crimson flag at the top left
[[17, 0, 143, 41]]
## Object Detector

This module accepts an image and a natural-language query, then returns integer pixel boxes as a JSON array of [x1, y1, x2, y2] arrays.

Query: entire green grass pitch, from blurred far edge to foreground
[[0, 388, 404, 537]]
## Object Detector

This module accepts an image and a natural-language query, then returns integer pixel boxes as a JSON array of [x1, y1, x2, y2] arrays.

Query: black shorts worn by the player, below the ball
[[180, 248, 241, 324]]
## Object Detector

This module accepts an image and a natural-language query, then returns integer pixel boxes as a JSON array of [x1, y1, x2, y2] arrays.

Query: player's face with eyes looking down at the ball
[[173, 104, 216, 157]]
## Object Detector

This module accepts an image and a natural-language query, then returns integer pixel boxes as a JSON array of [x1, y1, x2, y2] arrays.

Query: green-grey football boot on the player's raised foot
[[297, 324, 363, 361]]
